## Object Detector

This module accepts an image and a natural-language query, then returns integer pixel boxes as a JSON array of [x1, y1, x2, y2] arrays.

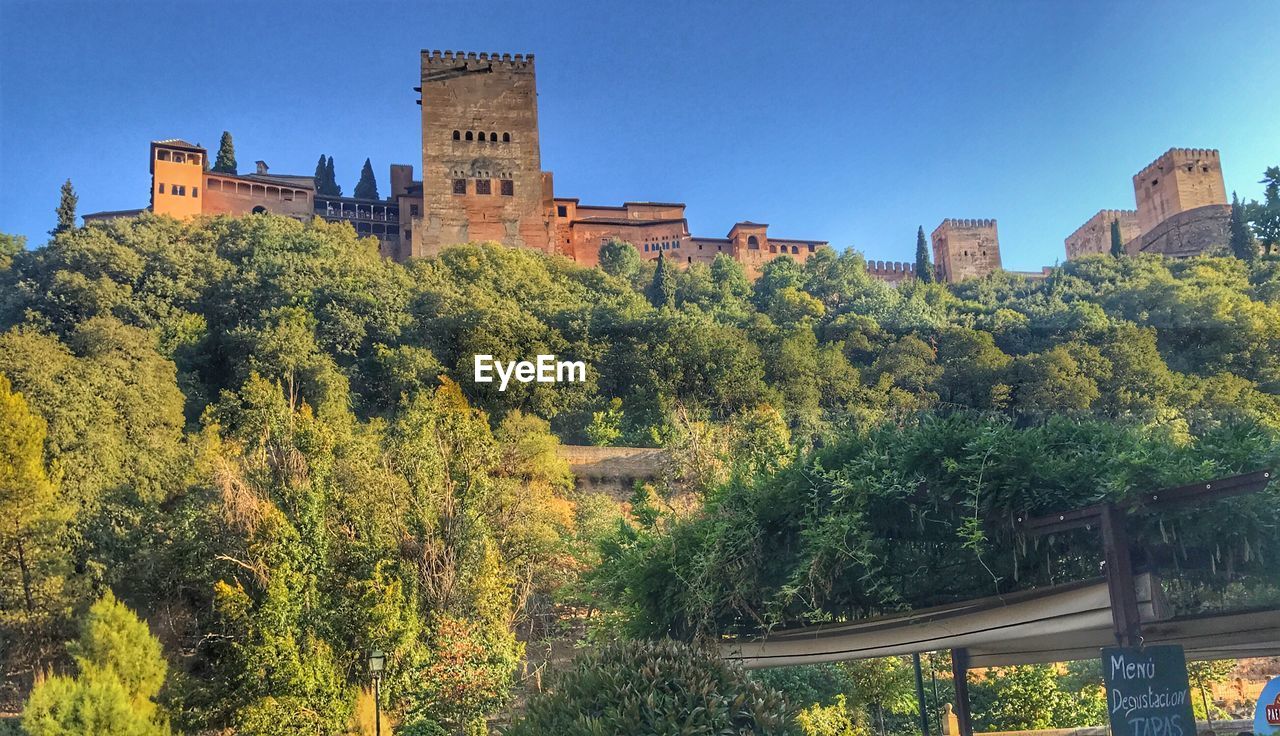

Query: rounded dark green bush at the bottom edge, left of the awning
[[507, 640, 799, 736]]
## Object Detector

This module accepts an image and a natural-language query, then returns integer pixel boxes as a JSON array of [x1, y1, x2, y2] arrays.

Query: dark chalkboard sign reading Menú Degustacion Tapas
[[1102, 646, 1196, 736]]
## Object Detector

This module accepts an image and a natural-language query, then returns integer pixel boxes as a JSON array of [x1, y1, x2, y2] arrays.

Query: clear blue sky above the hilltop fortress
[[0, 0, 1280, 269]]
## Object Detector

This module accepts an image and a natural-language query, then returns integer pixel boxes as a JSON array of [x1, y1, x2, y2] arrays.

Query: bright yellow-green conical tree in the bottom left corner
[[22, 591, 169, 736]]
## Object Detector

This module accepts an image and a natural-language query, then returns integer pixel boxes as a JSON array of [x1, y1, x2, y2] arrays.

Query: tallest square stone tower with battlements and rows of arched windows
[[410, 51, 553, 256]]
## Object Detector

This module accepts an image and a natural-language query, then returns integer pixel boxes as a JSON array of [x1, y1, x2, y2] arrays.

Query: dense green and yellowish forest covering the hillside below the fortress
[[0, 207, 1280, 736]]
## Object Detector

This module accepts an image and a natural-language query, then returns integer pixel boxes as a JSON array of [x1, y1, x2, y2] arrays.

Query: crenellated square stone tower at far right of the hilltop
[[1133, 148, 1226, 233]]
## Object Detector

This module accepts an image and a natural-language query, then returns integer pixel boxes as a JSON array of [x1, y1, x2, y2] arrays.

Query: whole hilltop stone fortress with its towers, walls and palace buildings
[[84, 51, 1230, 284]]
